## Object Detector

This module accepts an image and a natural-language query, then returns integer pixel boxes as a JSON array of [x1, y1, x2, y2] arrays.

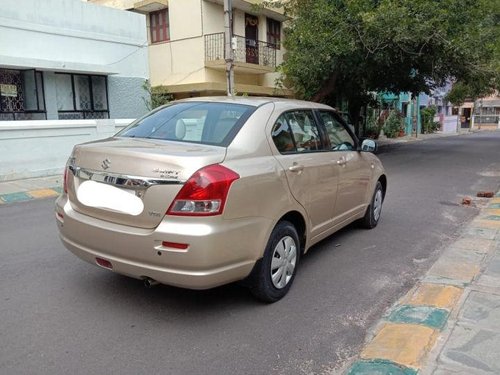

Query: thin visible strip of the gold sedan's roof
[[175, 96, 333, 110]]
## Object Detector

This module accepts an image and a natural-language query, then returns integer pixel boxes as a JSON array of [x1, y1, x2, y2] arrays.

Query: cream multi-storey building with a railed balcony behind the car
[[88, 0, 292, 99]]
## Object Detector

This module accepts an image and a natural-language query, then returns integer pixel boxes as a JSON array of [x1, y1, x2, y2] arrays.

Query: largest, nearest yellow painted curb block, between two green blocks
[[361, 323, 438, 369]]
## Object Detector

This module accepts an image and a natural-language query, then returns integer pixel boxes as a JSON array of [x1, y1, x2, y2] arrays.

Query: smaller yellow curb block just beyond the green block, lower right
[[406, 283, 463, 310]]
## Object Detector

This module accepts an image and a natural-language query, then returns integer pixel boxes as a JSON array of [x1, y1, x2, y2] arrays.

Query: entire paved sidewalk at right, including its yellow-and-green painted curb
[[346, 192, 500, 375]]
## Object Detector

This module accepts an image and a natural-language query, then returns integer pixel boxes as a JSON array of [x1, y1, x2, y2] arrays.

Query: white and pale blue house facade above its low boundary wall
[[0, 0, 149, 121]]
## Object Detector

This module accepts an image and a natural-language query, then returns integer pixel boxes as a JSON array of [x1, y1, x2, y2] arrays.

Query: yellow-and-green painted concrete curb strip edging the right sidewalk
[[346, 193, 500, 375]]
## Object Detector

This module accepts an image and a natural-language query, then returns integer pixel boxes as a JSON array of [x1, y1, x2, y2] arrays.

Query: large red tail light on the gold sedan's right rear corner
[[167, 164, 240, 216]]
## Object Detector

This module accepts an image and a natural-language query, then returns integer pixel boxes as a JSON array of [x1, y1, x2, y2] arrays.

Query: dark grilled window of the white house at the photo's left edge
[[0, 69, 47, 121]]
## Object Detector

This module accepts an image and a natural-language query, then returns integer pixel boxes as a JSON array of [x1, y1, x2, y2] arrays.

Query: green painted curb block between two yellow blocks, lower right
[[387, 305, 449, 329]]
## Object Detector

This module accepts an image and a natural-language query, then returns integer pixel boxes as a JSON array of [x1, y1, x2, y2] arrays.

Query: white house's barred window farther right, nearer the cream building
[[56, 73, 109, 120]]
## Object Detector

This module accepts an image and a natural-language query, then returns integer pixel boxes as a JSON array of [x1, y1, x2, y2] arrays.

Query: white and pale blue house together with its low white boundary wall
[[0, 0, 149, 181]]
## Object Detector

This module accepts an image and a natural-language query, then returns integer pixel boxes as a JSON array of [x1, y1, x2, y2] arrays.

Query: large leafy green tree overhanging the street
[[268, 0, 500, 131]]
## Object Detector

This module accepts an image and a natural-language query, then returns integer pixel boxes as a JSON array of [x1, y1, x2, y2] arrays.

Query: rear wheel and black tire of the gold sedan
[[249, 221, 300, 303]]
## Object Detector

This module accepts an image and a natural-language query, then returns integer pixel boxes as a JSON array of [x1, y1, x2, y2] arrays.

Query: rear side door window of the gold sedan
[[272, 110, 323, 153]]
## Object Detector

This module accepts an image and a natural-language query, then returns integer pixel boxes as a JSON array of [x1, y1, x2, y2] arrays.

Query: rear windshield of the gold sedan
[[117, 102, 255, 146]]
